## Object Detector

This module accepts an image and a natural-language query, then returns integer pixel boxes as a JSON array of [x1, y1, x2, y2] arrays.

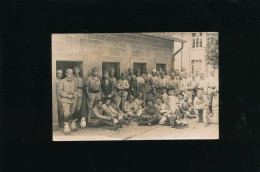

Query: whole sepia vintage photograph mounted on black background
[[52, 32, 219, 141]]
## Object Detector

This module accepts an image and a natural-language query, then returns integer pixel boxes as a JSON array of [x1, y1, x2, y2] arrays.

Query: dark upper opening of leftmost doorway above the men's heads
[[56, 61, 83, 78]]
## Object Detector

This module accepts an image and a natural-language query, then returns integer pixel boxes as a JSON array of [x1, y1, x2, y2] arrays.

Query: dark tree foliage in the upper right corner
[[206, 33, 219, 69]]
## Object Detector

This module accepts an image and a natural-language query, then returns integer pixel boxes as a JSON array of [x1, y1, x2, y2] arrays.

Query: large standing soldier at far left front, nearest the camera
[[58, 69, 77, 134]]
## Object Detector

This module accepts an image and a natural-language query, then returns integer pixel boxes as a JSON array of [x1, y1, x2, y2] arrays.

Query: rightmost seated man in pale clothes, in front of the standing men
[[194, 90, 209, 127]]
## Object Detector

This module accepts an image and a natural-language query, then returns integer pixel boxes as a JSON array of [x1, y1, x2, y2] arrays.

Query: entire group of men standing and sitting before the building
[[56, 66, 218, 134]]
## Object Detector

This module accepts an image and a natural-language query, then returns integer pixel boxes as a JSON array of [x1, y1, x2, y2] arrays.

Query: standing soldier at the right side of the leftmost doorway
[[72, 66, 83, 119]]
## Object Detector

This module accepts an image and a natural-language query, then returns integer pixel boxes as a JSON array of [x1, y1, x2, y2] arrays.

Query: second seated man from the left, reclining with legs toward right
[[102, 98, 125, 126]]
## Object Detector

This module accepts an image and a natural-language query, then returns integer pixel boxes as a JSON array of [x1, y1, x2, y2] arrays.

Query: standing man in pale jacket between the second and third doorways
[[117, 73, 129, 111]]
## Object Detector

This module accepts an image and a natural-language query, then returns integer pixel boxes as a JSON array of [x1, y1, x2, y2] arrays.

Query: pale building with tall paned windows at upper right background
[[151, 32, 218, 76]]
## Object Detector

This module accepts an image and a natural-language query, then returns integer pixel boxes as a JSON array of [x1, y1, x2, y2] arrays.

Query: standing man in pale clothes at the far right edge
[[204, 70, 218, 117]]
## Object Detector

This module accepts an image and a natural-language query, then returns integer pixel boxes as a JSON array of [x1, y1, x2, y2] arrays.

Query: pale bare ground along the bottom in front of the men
[[53, 115, 219, 141]]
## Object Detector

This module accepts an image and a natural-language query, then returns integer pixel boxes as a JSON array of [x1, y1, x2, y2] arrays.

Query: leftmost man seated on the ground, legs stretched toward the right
[[89, 99, 118, 129]]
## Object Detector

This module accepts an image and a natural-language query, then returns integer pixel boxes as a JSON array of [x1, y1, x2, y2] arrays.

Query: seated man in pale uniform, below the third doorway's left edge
[[124, 95, 143, 118]]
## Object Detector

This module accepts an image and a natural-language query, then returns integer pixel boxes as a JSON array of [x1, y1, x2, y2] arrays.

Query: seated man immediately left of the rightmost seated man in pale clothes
[[179, 94, 196, 118]]
